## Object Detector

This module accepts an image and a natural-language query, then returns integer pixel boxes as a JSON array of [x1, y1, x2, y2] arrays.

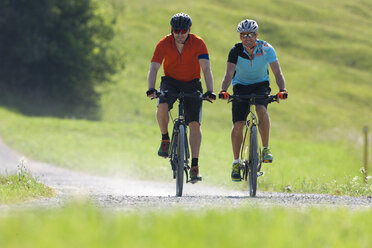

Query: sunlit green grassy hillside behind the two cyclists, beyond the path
[[0, 0, 372, 195]]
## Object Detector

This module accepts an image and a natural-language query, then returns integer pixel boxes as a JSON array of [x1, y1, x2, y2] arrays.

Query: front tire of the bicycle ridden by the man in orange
[[176, 125, 185, 196]]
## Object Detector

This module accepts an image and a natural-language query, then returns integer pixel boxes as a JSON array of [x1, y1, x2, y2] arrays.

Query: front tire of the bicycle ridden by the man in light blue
[[249, 125, 258, 197]]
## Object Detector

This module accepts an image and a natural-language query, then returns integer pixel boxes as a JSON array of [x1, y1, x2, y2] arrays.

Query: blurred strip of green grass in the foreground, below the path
[[0, 203, 372, 248]]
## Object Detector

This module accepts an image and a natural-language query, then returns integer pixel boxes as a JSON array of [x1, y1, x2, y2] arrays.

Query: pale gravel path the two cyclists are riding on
[[0, 141, 372, 211]]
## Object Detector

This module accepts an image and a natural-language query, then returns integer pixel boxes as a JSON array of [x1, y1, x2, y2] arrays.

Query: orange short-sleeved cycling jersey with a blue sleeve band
[[151, 34, 209, 82]]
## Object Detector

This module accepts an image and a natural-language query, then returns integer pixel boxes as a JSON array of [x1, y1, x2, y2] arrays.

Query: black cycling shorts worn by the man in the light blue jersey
[[232, 82, 271, 123]]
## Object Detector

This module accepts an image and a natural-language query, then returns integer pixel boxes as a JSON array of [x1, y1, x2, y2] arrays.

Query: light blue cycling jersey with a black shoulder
[[228, 39, 278, 86]]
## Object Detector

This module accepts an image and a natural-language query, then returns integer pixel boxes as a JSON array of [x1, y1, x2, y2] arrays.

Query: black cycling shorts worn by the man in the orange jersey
[[158, 76, 203, 125]]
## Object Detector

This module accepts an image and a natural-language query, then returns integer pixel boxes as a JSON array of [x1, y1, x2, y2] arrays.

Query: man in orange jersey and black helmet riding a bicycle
[[146, 13, 216, 182]]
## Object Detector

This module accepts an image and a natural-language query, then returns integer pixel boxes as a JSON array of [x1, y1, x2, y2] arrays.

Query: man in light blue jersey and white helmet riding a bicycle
[[220, 19, 288, 181]]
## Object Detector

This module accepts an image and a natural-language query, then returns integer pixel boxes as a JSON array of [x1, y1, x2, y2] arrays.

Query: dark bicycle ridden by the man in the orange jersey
[[156, 91, 211, 196]]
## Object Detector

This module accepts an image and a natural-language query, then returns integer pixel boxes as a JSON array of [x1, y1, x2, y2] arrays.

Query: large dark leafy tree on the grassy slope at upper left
[[0, 0, 122, 119]]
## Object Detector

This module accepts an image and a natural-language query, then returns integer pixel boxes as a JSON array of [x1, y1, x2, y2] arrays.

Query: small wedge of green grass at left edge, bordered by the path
[[0, 163, 54, 205]]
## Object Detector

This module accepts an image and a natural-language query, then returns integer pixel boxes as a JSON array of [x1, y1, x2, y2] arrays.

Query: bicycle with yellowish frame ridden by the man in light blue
[[219, 95, 277, 197]]
